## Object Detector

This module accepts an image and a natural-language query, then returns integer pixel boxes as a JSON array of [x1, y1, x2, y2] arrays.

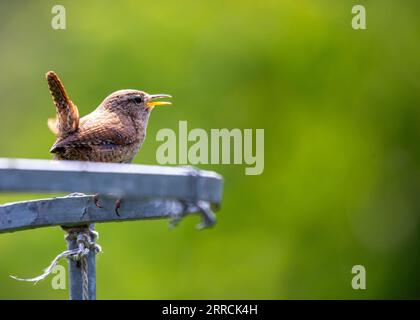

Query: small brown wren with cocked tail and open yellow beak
[[46, 71, 172, 215]]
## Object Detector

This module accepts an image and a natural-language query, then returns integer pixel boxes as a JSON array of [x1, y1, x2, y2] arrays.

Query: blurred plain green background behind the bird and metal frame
[[0, 0, 420, 299]]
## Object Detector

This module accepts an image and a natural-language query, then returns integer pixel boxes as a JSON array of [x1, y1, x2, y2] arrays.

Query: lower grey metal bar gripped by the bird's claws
[[0, 195, 202, 233]]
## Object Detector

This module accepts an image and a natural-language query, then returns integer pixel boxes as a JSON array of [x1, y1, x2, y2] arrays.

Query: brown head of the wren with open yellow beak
[[101, 90, 172, 119]]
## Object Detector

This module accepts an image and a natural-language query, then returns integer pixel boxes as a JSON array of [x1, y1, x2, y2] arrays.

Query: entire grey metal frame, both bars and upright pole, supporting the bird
[[0, 158, 223, 299]]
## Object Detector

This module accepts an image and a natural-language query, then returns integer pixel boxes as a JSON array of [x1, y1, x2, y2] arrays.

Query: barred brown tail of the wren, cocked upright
[[46, 71, 79, 138]]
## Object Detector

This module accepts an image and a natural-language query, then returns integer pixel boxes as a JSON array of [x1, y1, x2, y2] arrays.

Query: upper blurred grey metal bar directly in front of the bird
[[0, 158, 223, 204]]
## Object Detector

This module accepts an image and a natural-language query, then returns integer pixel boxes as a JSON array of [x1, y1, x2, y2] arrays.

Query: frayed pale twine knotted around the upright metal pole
[[10, 226, 102, 300]]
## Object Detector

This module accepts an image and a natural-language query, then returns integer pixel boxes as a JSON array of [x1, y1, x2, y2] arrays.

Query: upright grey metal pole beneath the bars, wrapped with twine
[[66, 224, 96, 300]]
